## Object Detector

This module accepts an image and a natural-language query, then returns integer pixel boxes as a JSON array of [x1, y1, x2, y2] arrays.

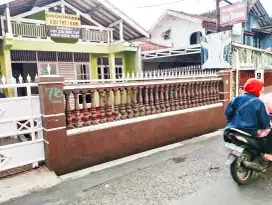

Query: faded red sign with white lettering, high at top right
[[220, 1, 248, 26]]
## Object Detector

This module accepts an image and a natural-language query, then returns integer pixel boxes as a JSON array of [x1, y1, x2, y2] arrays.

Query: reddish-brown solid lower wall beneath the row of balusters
[[54, 106, 225, 174]]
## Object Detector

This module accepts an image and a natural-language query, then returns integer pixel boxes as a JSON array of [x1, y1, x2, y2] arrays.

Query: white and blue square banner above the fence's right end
[[201, 31, 232, 69]]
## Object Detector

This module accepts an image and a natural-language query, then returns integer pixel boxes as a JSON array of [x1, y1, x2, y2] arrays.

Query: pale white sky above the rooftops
[[108, 0, 272, 30]]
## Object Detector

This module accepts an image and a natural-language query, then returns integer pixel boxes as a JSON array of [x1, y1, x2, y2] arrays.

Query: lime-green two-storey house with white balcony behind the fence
[[0, 0, 149, 95]]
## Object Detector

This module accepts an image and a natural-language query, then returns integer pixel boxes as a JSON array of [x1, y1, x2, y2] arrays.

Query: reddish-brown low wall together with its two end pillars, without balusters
[[39, 71, 230, 175]]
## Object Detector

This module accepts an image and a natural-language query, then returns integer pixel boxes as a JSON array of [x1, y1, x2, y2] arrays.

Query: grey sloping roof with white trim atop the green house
[[0, 0, 149, 41]]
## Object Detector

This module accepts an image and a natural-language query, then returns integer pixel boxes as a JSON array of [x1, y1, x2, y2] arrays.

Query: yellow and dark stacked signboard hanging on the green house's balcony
[[45, 12, 81, 39]]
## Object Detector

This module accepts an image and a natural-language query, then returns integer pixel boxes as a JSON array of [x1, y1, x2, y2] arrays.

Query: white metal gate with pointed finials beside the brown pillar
[[0, 76, 45, 171]]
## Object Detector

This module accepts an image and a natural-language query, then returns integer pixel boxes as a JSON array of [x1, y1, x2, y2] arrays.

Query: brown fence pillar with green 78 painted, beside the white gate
[[38, 76, 67, 174]]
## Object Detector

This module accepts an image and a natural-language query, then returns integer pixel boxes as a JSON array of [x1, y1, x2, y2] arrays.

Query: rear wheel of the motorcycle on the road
[[230, 151, 253, 185]]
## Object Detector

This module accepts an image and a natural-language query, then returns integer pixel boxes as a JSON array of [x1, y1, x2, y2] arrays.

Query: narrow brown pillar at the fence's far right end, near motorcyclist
[[219, 70, 232, 110]]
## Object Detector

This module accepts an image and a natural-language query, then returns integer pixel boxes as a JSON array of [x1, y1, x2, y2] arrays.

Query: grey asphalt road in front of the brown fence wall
[[1, 131, 272, 205]]
